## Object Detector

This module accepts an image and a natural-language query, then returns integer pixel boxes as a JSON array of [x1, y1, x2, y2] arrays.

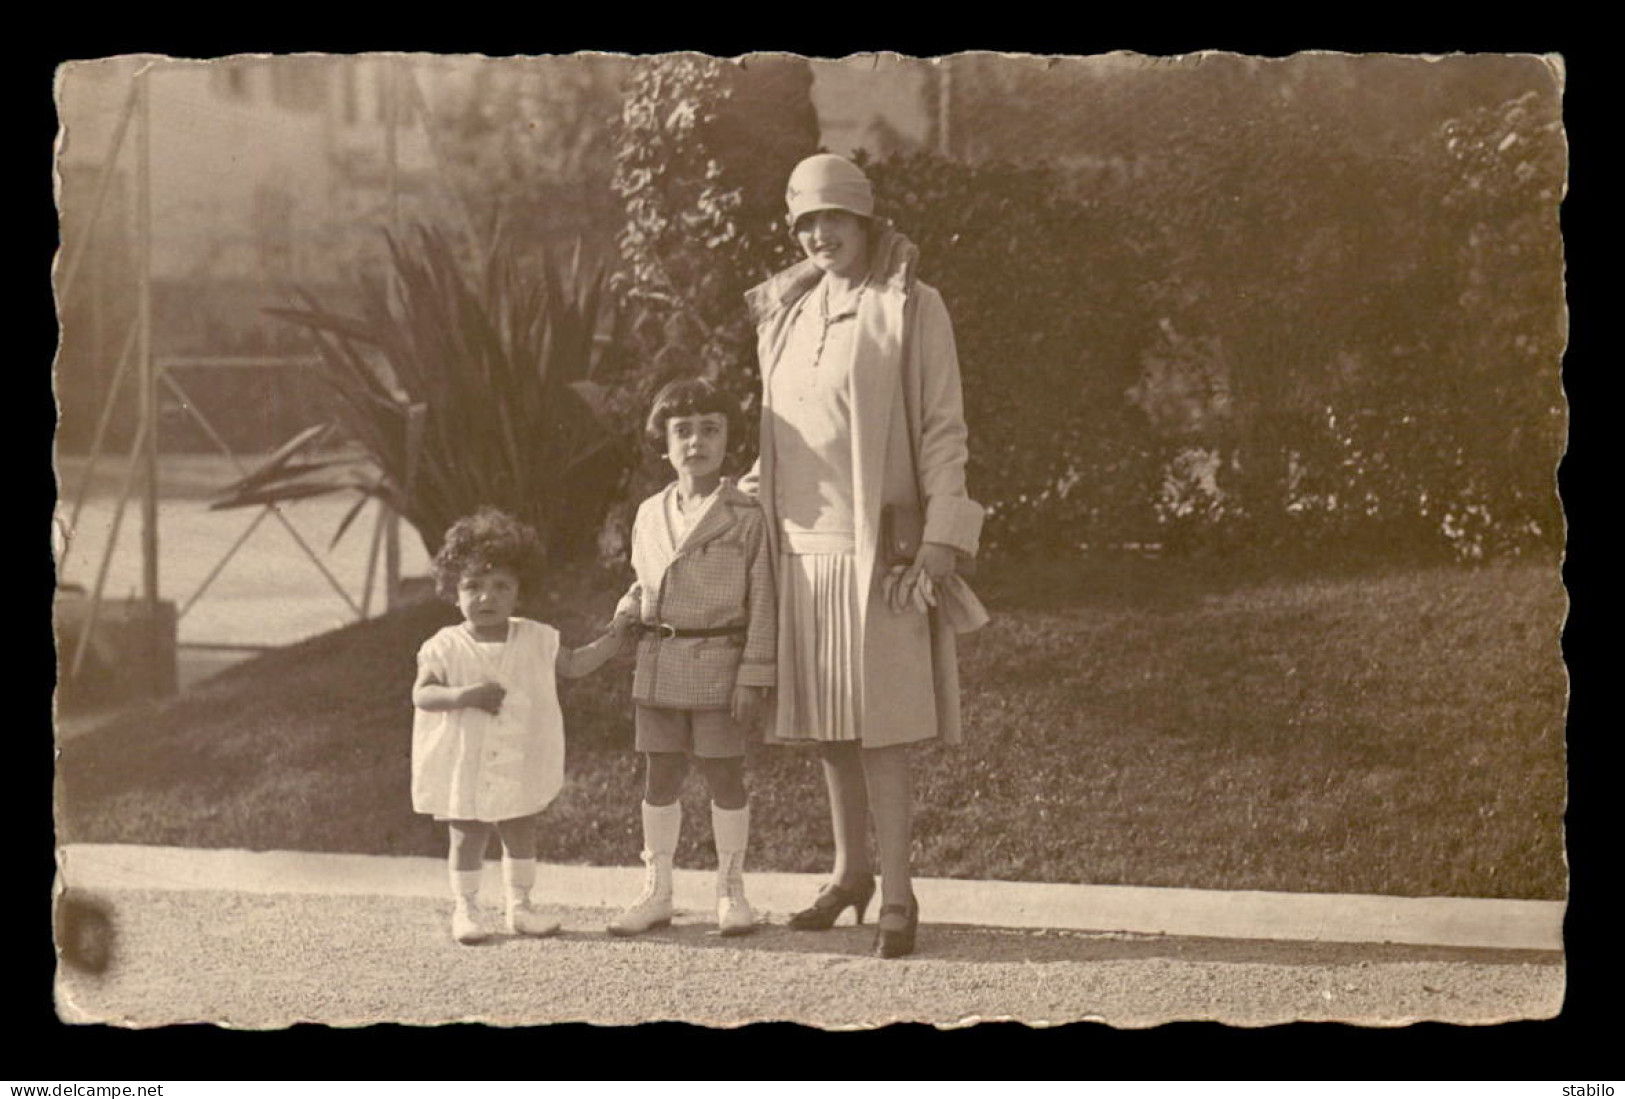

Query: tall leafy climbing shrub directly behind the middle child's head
[[603, 54, 817, 558]]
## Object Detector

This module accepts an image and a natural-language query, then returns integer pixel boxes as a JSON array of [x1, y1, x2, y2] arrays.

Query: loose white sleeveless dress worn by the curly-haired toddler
[[411, 618, 564, 821]]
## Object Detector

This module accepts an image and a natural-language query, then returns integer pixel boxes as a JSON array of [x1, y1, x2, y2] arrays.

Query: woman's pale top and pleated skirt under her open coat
[[769, 285, 863, 740]]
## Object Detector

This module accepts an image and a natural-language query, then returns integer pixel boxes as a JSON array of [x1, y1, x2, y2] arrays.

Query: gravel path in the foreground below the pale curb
[[57, 891, 1563, 1027]]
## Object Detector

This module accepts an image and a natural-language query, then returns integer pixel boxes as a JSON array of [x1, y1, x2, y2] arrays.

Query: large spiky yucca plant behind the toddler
[[232, 229, 626, 554]]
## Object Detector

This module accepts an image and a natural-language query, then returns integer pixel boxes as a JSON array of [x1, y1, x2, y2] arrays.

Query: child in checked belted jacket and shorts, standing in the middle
[[609, 377, 778, 935]]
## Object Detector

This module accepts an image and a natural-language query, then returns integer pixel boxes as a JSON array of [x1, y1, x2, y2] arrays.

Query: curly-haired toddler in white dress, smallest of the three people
[[411, 507, 621, 945]]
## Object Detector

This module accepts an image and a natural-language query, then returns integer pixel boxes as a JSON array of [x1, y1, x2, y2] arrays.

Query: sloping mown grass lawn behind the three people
[[57, 559, 1567, 899]]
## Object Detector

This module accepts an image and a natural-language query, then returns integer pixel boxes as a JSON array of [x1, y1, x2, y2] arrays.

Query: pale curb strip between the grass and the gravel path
[[57, 844, 1567, 951]]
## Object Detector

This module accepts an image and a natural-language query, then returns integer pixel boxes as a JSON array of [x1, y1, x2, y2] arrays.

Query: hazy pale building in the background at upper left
[[57, 57, 474, 450]]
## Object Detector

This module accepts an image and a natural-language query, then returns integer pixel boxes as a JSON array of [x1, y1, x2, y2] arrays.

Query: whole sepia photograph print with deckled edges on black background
[[50, 52, 1570, 1031]]
